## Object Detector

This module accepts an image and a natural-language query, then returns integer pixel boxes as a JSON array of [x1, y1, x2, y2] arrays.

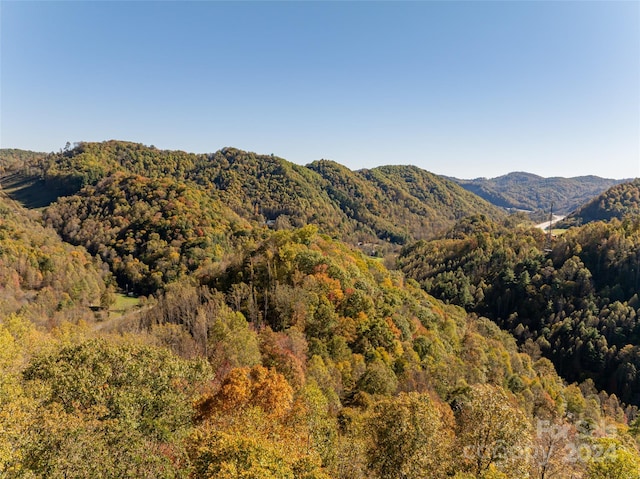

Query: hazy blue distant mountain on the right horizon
[[452, 172, 624, 214]]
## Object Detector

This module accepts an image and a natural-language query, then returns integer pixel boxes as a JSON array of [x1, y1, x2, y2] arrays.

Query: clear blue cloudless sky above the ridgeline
[[0, 0, 640, 178]]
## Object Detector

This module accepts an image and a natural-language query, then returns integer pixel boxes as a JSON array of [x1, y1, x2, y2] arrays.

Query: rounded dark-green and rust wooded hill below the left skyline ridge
[[45, 173, 249, 294]]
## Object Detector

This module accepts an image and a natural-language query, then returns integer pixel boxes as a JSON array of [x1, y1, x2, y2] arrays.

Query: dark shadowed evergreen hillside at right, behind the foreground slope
[[400, 217, 640, 404]]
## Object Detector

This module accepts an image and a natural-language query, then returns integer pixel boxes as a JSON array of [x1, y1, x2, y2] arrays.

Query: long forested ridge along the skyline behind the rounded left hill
[[5, 141, 504, 248]]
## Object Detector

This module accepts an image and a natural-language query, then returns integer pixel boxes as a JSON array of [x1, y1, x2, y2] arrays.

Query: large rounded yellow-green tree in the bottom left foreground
[[18, 340, 210, 478]]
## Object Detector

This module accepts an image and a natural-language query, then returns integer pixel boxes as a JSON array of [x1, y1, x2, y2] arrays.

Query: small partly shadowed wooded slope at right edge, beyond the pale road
[[563, 178, 640, 225]]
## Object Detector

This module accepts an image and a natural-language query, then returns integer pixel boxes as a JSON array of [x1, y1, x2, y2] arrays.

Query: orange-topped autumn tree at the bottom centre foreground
[[187, 366, 328, 479]]
